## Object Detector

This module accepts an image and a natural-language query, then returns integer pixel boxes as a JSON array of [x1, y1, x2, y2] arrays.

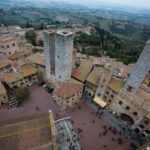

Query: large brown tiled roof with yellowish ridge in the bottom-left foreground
[[0, 114, 55, 150]]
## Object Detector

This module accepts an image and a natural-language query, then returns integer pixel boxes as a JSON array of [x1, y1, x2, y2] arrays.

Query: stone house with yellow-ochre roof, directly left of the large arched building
[[103, 78, 124, 106]]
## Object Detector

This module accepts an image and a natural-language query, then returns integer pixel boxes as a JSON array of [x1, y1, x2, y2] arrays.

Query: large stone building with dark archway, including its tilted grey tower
[[104, 41, 150, 137]]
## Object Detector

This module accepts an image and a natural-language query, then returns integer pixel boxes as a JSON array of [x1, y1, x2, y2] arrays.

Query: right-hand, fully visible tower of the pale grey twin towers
[[55, 31, 74, 82]]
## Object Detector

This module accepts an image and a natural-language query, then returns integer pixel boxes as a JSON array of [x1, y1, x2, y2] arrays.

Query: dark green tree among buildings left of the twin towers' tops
[[25, 31, 36, 46]]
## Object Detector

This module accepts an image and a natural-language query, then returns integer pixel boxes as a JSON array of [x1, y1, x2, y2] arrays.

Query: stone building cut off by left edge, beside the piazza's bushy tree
[[0, 82, 8, 106]]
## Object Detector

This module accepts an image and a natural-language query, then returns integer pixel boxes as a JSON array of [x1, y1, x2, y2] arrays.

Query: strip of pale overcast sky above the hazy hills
[[56, 0, 150, 8]]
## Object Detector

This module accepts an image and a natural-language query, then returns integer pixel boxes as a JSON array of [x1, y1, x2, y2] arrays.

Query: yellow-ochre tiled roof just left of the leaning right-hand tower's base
[[108, 78, 124, 93]]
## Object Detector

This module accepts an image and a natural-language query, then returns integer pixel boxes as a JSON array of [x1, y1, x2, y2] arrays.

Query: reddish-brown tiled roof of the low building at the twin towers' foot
[[54, 83, 83, 99]]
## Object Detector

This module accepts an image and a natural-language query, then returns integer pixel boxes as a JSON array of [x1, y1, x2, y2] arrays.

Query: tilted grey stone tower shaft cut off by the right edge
[[124, 40, 150, 93]]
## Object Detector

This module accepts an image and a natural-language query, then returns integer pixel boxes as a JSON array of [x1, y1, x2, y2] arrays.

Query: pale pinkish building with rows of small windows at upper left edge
[[0, 36, 19, 57]]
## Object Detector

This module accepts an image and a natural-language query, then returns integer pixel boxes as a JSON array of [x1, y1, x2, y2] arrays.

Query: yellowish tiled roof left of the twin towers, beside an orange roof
[[20, 66, 37, 77]]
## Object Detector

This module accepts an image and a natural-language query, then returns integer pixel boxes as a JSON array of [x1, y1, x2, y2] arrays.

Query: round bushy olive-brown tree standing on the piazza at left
[[14, 87, 30, 103]]
